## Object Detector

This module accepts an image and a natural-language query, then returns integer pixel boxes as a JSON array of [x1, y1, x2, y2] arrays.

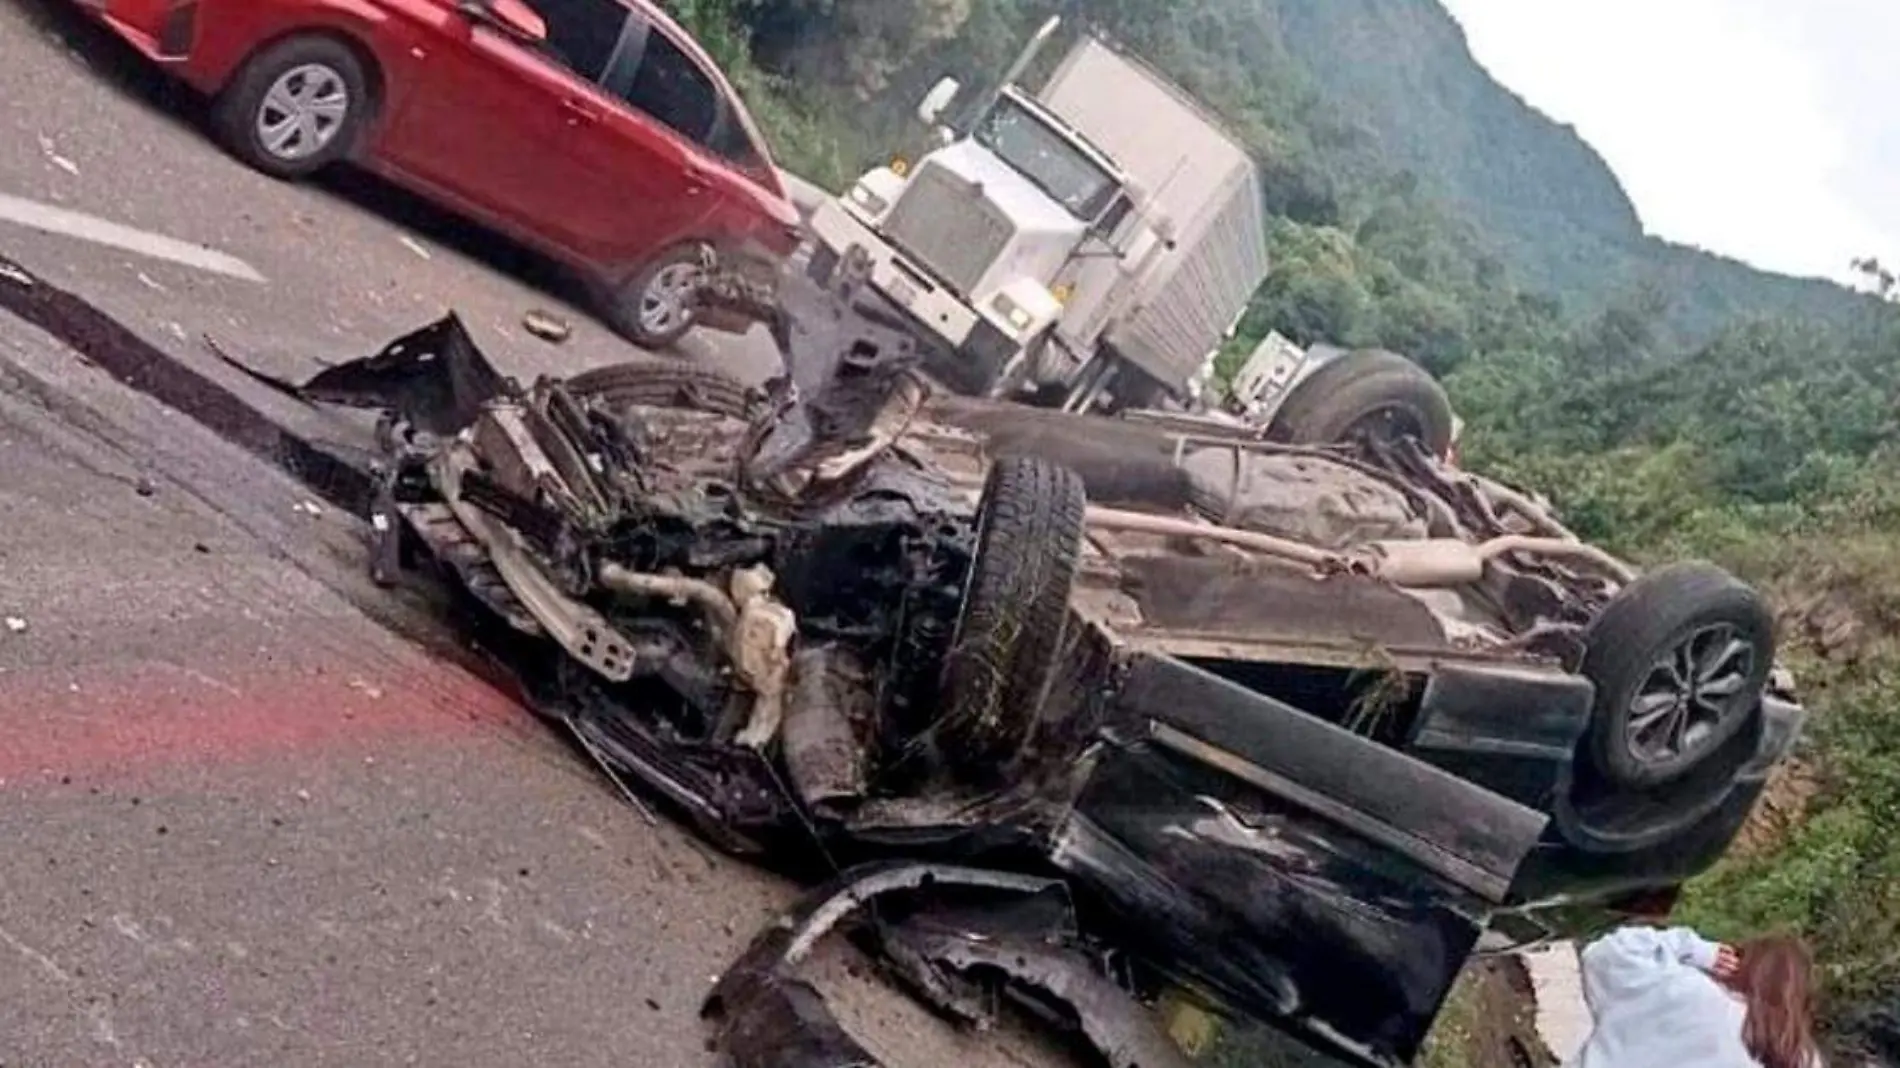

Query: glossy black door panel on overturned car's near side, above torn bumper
[[1053, 743, 1488, 1066]]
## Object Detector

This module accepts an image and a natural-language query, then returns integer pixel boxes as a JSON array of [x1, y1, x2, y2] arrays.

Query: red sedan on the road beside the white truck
[[80, 0, 798, 348]]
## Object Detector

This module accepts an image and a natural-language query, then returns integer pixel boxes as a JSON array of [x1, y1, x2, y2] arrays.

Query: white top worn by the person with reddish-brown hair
[[1566, 927, 1759, 1068]]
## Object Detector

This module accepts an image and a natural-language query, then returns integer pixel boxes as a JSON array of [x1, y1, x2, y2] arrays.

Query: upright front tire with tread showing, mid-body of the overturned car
[[937, 456, 1089, 772]]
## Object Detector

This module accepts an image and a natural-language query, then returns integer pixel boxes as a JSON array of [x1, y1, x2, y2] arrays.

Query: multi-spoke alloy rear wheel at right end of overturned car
[[1583, 563, 1775, 789]]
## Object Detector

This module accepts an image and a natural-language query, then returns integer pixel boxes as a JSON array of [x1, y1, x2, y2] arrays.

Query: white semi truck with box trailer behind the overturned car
[[811, 19, 1267, 410]]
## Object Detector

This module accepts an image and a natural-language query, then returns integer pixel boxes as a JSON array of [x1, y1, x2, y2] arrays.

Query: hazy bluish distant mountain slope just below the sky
[[1271, 0, 1864, 334]]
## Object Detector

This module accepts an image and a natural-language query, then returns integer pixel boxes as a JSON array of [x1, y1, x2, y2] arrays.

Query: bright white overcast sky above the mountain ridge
[[1444, 0, 1900, 279]]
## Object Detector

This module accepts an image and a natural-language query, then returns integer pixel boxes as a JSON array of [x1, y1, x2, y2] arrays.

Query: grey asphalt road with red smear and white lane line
[[0, 0, 1051, 1068]]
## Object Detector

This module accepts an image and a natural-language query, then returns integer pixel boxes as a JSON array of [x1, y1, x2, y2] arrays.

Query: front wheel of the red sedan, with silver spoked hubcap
[[211, 34, 374, 179]]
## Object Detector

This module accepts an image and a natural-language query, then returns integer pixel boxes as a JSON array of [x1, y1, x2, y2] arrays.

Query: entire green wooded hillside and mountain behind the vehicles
[[671, 0, 1900, 1048]]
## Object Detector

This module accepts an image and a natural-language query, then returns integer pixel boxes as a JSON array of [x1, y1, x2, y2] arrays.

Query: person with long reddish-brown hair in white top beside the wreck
[[1566, 927, 1822, 1068]]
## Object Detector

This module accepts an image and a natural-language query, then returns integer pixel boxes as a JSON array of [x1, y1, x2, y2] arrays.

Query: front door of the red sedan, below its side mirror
[[382, 0, 629, 260]]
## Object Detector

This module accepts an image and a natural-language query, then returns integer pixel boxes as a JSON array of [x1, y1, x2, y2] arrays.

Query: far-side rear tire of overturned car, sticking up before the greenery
[[1267, 348, 1454, 456]]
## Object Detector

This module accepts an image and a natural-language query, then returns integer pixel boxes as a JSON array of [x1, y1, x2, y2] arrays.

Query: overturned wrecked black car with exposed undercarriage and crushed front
[[277, 250, 1801, 1068]]
